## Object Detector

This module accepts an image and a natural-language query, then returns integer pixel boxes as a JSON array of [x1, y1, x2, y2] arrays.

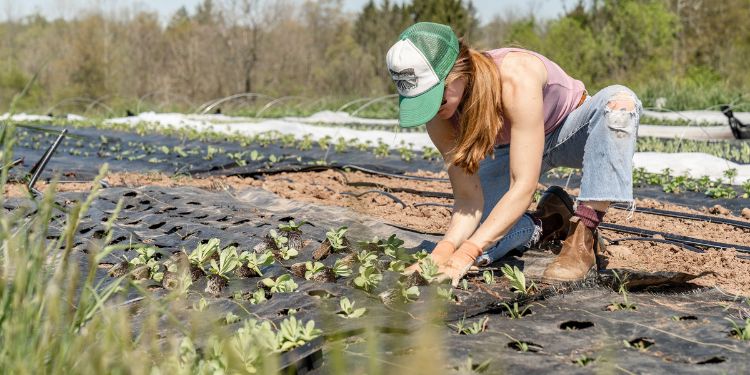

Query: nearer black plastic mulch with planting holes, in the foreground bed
[[6, 187, 750, 374]]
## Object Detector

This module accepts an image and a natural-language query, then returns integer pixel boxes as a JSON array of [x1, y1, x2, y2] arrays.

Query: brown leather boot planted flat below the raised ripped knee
[[542, 216, 596, 282]]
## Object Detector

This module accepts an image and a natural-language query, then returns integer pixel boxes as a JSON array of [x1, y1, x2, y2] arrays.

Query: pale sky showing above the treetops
[[0, 0, 578, 22]]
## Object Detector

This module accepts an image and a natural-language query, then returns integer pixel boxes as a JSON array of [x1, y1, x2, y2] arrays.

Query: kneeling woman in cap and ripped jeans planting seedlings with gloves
[[386, 22, 642, 285]]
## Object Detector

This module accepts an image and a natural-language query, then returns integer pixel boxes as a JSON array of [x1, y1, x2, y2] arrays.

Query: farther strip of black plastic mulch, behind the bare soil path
[[7, 127, 750, 213]]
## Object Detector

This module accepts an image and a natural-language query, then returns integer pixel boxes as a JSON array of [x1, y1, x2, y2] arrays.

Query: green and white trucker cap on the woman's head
[[386, 22, 458, 128]]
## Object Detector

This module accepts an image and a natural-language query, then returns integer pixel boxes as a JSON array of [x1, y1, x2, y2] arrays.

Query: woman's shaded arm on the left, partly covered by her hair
[[427, 116, 484, 247]]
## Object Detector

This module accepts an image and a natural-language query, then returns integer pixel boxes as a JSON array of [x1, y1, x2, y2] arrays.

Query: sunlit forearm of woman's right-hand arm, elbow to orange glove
[[470, 186, 534, 249]]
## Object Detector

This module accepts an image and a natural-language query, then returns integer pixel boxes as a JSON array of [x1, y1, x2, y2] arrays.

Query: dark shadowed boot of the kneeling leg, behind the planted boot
[[531, 186, 573, 245]]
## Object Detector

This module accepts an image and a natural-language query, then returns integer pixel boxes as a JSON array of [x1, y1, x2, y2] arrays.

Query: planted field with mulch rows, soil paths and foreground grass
[[0, 112, 750, 374]]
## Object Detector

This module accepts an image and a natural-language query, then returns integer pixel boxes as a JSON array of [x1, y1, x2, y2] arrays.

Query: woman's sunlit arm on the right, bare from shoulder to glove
[[469, 52, 547, 249]]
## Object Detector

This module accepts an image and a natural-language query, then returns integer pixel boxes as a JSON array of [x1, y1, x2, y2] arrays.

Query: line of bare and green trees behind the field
[[0, 0, 750, 112]]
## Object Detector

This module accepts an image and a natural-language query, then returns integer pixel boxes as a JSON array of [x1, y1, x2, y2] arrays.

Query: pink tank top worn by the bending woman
[[451, 48, 586, 145]]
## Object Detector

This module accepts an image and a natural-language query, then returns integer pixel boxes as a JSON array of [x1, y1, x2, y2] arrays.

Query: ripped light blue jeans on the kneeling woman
[[477, 85, 643, 266]]
